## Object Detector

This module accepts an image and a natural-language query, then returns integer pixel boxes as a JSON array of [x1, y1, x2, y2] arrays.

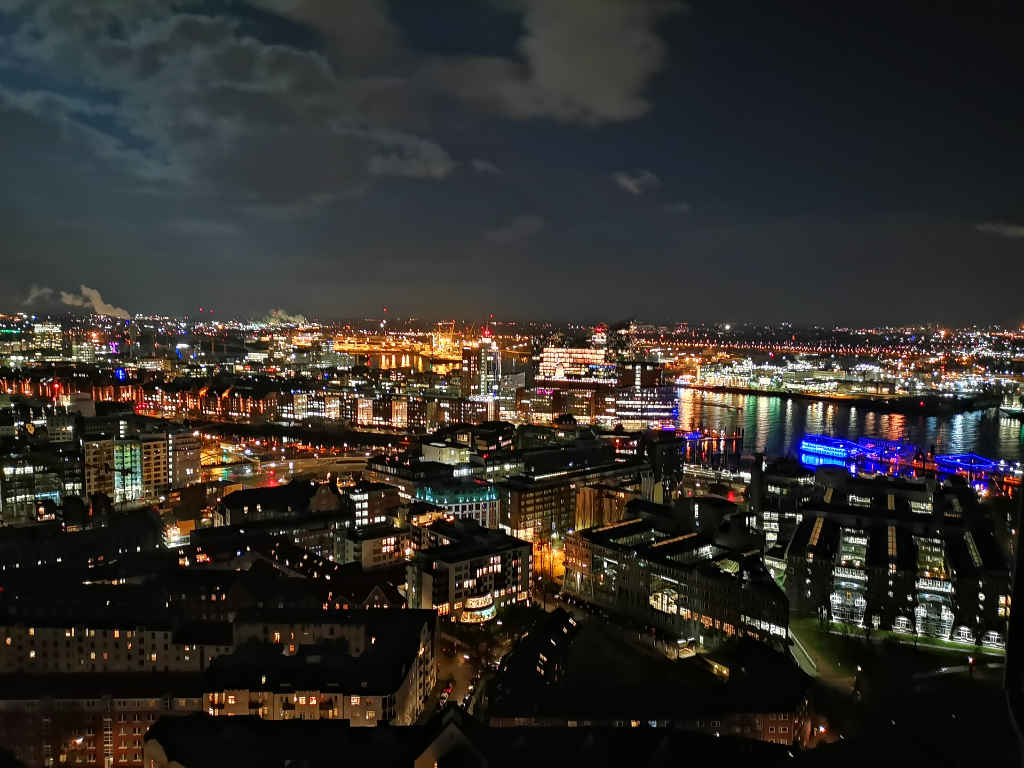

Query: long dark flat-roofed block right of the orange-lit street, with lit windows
[[563, 518, 790, 647]]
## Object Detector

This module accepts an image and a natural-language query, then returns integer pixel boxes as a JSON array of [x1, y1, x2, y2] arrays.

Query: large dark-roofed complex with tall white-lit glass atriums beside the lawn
[[785, 481, 1010, 647]]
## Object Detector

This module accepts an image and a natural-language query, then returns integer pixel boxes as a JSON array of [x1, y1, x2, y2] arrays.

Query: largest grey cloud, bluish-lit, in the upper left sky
[[2, 0, 454, 210]]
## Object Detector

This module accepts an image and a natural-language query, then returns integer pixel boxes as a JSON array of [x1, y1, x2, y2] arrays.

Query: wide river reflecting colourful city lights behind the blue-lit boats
[[679, 389, 1024, 462]]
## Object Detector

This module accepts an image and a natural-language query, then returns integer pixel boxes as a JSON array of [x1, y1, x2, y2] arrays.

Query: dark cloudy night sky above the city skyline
[[0, 0, 1024, 325]]
